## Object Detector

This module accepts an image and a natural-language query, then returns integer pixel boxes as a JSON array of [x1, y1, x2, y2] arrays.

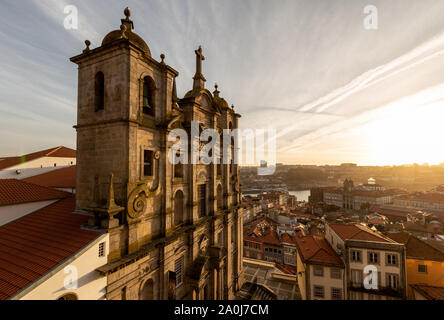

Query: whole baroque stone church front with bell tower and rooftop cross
[[71, 8, 243, 299]]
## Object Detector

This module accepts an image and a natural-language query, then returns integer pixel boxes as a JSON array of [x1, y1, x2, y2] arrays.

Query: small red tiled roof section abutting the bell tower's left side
[[23, 166, 76, 188]]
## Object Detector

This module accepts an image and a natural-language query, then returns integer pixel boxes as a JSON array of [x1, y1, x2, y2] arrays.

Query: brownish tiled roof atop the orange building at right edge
[[388, 232, 444, 261]]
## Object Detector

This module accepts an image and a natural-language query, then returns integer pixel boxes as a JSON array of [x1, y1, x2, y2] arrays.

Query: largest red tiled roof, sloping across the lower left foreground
[[0, 196, 100, 300]]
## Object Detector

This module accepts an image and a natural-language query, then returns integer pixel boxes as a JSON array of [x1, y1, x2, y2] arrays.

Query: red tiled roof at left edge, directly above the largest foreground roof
[[0, 179, 69, 206]]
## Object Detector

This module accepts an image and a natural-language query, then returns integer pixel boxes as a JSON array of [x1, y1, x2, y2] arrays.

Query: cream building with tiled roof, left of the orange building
[[325, 223, 407, 300]]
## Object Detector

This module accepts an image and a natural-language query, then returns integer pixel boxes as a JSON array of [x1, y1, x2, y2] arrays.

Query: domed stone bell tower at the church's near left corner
[[71, 8, 178, 258]]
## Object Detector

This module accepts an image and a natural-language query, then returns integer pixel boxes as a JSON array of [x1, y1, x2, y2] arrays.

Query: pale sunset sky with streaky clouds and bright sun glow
[[0, 0, 444, 165]]
